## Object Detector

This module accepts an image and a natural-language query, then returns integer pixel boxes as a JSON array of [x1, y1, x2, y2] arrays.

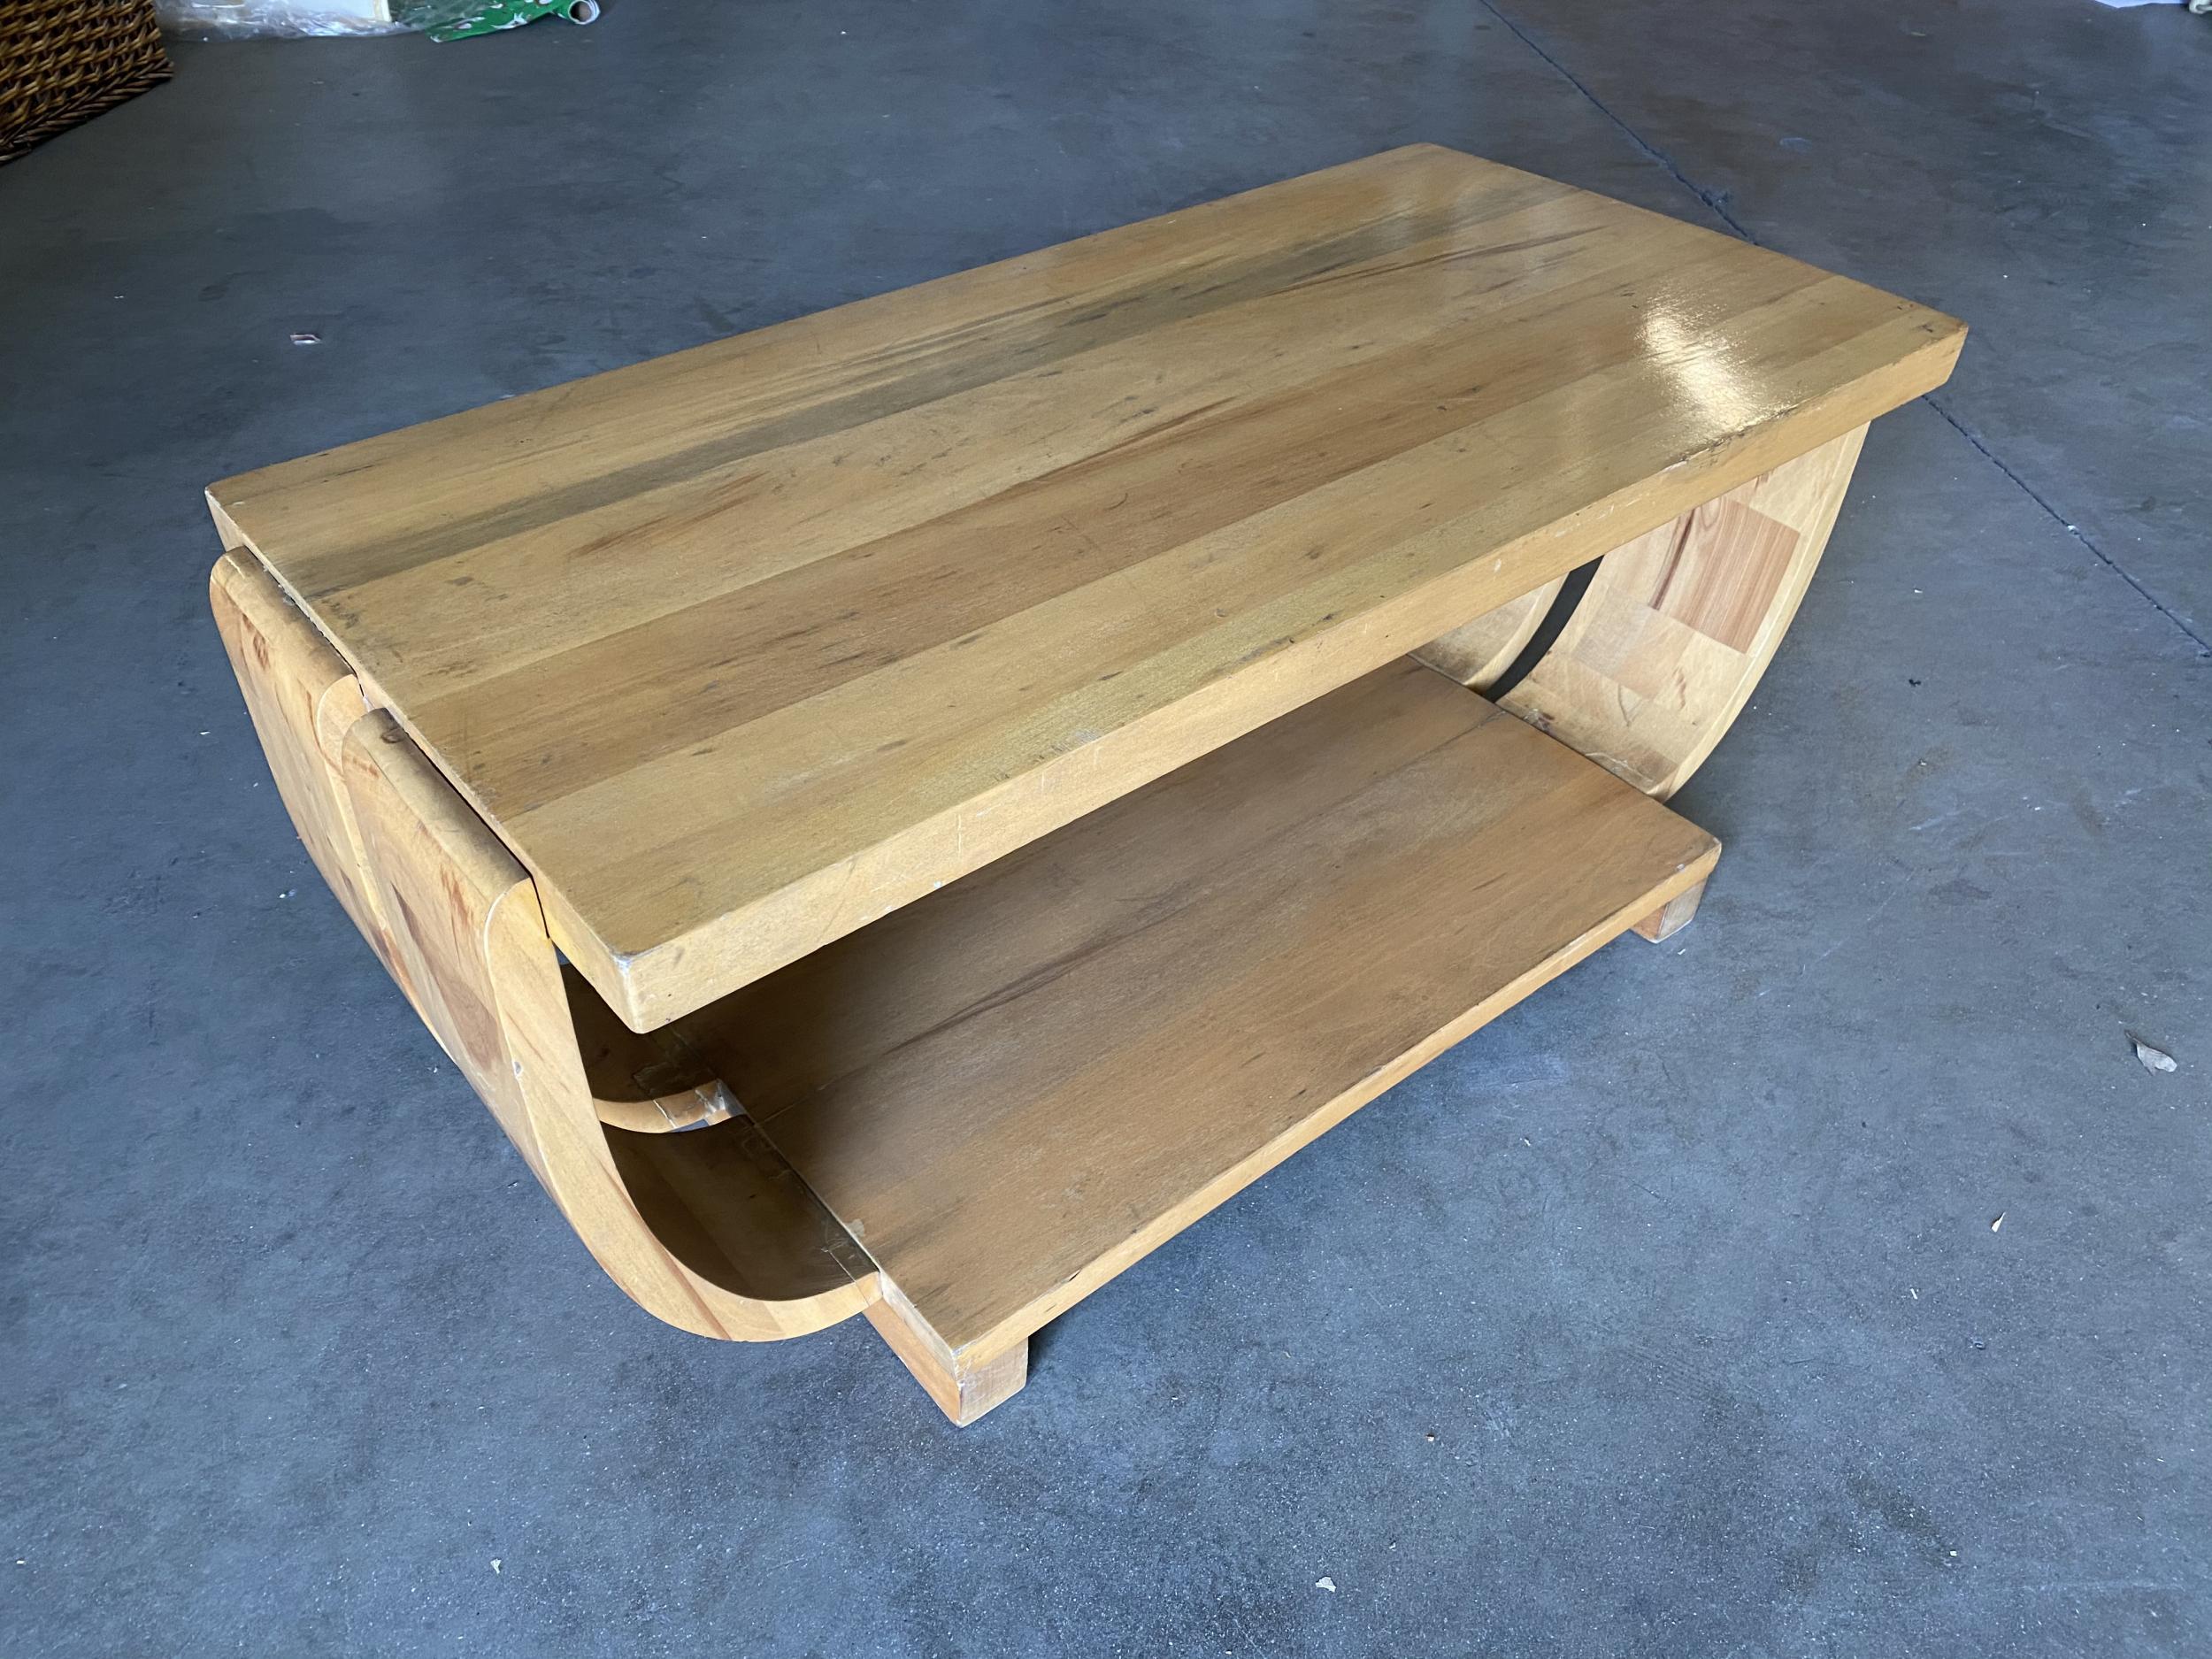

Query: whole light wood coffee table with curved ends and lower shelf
[[208, 146, 1964, 1423]]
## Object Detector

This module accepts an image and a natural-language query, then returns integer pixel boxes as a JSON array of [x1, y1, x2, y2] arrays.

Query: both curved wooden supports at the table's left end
[[211, 556, 880, 1340]]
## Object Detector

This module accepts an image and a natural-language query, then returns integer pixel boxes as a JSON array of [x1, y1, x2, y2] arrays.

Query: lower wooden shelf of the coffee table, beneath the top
[[671, 659, 1719, 1367]]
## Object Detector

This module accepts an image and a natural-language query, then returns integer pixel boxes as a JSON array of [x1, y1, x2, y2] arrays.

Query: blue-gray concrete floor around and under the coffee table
[[0, 0, 2212, 1659]]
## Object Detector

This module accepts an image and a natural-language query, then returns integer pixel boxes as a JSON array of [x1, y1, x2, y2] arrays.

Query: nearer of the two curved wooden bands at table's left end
[[343, 710, 876, 1340]]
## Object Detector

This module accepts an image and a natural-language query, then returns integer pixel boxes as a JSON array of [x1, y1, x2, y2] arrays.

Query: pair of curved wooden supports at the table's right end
[[1416, 427, 1867, 801]]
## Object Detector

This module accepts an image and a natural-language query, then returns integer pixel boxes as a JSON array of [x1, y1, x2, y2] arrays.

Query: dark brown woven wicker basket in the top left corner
[[0, 0, 168, 162]]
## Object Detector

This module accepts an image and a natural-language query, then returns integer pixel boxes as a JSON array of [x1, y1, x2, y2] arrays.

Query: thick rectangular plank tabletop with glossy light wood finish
[[208, 146, 1964, 1031]]
